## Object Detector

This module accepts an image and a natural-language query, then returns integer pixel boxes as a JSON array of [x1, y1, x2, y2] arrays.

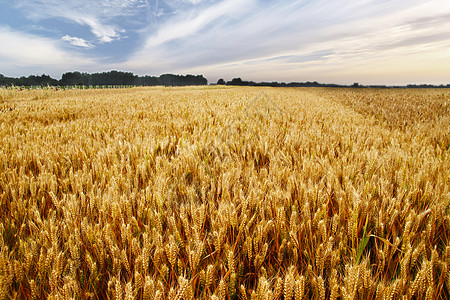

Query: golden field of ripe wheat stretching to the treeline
[[0, 86, 450, 300]]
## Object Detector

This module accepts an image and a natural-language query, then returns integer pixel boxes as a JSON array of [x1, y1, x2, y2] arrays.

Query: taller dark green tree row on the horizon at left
[[0, 71, 208, 86]]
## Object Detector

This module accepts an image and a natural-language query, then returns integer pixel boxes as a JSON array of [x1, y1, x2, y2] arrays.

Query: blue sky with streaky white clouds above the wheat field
[[0, 0, 450, 85]]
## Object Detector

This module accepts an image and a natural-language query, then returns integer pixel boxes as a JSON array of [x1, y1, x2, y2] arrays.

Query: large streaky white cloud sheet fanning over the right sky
[[126, 0, 450, 83]]
